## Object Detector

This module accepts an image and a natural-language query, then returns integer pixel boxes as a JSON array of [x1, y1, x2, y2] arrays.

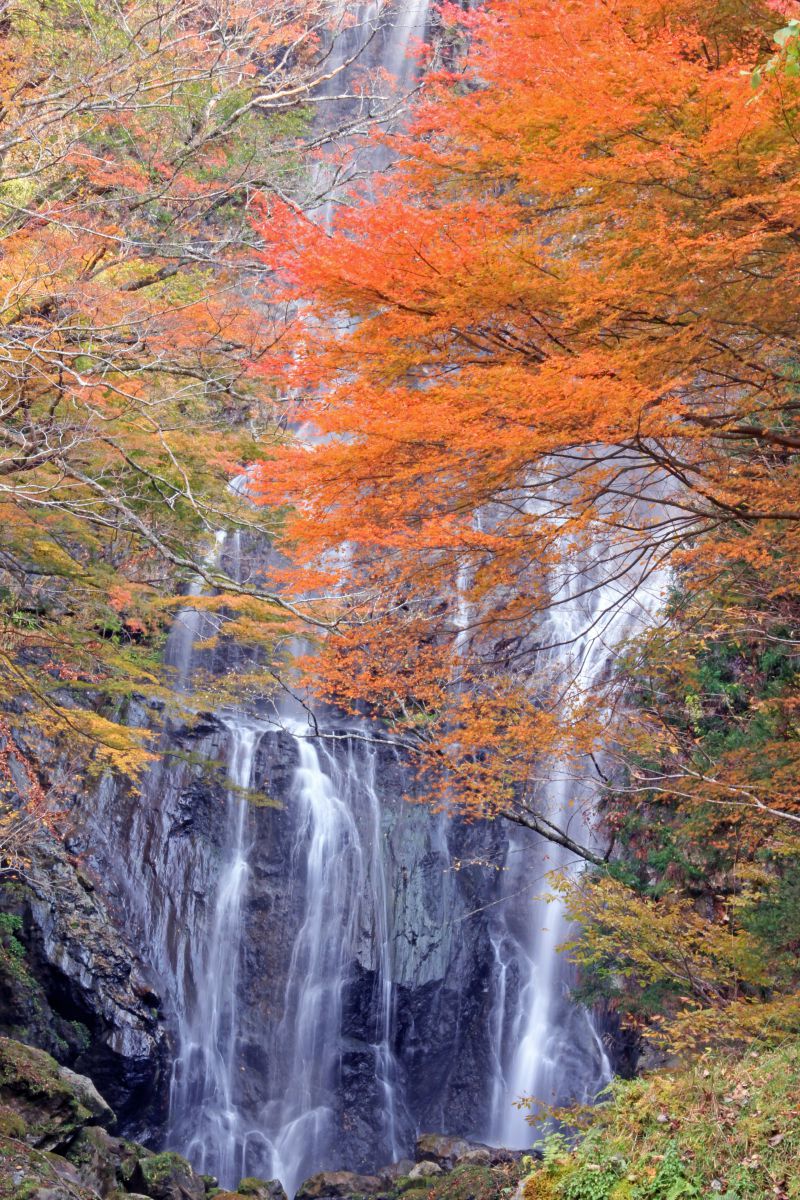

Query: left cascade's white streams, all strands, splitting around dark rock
[[157, 533, 408, 1194]]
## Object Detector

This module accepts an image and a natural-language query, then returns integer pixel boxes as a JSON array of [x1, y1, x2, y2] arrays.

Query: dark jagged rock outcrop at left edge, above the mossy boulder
[[0, 830, 169, 1135]]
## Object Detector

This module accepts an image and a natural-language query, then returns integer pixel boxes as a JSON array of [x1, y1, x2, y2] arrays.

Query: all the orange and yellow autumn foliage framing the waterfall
[[0, 0, 800, 1060]]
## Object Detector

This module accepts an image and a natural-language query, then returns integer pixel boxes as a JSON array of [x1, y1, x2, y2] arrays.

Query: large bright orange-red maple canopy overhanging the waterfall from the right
[[255, 0, 800, 857]]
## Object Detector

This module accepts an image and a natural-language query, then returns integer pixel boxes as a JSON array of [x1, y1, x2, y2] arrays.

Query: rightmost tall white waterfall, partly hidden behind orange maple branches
[[488, 518, 663, 1148]]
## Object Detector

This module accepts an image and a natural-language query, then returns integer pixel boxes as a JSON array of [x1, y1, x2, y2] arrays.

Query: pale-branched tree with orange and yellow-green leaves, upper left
[[0, 0, 410, 768]]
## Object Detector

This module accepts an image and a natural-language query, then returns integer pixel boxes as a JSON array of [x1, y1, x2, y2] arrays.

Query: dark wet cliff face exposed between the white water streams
[[64, 700, 513, 1186]]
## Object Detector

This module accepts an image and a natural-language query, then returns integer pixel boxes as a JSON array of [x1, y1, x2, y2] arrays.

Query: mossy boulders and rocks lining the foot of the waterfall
[[0, 1037, 532, 1200]]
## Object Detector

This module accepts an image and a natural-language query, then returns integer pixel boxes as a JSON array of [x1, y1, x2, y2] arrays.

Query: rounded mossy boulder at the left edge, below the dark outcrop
[[0, 1038, 92, 1150]]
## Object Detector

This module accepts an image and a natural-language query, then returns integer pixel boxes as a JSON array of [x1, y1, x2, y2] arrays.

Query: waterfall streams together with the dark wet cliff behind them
[[67, 0, 657, 1194]]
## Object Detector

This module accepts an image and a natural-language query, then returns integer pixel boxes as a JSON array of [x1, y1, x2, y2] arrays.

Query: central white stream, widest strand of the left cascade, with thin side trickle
[[256, 722, 399, 1194]]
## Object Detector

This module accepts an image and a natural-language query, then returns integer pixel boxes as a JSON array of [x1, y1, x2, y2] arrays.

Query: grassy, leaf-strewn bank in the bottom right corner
[[524, 1042, 800, 1200]]
